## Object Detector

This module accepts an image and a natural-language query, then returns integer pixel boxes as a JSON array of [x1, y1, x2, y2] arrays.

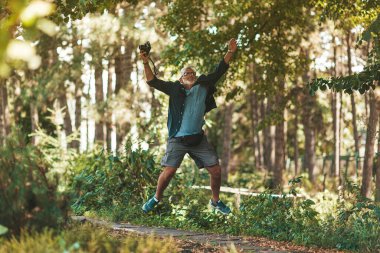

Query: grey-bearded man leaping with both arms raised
[[140, 39, 237, 215]]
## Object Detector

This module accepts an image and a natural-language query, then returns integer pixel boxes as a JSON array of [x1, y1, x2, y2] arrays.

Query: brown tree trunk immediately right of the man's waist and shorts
[[221, 103, 234, 182]]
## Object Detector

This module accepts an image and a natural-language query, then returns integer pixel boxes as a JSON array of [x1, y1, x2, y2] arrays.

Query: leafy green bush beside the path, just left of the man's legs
[[69, 141, 160, 214]]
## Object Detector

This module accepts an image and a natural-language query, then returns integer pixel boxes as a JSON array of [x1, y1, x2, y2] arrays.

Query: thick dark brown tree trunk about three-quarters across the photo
[[274, 80, 285, 187]]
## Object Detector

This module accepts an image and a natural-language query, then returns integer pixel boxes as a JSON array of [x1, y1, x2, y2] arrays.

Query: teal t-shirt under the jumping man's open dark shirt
[[175, 85, 207, 137]]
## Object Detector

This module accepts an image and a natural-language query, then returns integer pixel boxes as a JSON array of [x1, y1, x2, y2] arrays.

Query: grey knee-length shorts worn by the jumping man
[[161, 135, 219, 168]]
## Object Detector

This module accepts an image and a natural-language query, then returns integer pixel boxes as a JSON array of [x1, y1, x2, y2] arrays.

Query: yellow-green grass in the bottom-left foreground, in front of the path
[[0, 224, 180, 253]]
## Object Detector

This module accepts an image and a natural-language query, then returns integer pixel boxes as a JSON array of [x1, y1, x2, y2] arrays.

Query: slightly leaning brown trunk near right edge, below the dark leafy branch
[[361, 90, 379, 198]]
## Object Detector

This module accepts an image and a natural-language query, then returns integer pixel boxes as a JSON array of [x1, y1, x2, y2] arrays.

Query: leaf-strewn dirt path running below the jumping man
[[72, 216, 348, 253]]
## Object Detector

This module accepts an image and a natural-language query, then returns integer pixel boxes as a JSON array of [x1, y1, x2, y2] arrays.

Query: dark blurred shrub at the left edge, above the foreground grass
[[0, 130, 66, 233]]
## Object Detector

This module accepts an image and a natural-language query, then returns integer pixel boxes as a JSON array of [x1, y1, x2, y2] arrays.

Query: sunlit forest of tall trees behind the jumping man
[[0, 0, 380, 201]]
